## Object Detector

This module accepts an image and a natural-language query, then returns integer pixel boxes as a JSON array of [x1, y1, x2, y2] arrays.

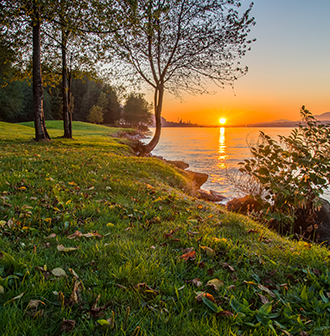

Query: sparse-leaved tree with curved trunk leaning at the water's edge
[[117, 0, 254, 155]]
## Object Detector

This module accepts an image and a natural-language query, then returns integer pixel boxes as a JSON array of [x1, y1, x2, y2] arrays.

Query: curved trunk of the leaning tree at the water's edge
[[138, 84, 164, 156]]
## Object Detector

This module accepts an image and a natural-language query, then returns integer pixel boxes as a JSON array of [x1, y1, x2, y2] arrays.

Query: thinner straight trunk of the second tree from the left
[[61, 28, 72, 139]]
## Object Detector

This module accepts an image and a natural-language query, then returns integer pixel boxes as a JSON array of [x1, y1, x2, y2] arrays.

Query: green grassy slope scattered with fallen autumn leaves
[[0, 121, 330, 335]]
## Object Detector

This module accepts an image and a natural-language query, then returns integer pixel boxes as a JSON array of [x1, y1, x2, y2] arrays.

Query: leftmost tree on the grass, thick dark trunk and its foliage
[[0, 0, 53, 141]]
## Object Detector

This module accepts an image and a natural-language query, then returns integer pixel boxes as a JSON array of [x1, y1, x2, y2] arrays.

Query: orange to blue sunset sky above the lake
[[147, 0, 330, 125]]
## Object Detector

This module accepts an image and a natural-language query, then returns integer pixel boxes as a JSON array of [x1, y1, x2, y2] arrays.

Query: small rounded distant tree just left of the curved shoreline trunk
[[123, 93, 153, 127]]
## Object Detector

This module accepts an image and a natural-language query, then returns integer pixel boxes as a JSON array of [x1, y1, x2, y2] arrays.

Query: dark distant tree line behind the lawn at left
[[0, 40, 152, 128]]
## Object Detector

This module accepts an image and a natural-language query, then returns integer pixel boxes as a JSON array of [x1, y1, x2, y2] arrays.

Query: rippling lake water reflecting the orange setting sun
[[144, 127, 330, 200]]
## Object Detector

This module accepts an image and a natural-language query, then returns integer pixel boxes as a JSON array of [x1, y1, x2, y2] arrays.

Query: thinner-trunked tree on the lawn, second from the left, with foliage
[[46, 0, 102, 138]]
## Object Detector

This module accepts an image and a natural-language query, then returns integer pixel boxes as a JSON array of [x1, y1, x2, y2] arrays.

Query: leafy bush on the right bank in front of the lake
[[240, 106, 330, 233]]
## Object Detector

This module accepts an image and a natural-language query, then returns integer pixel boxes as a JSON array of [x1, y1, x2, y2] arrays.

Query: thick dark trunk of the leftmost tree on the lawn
[[32, 5, 50, 141]]
